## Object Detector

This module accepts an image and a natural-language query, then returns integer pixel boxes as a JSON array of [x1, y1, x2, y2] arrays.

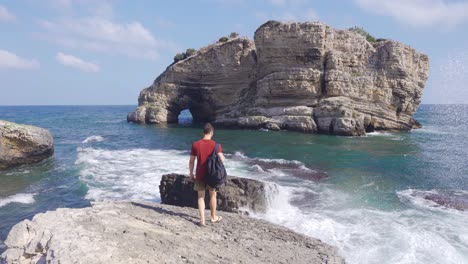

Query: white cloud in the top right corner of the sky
[[354, 0, 468, 27]]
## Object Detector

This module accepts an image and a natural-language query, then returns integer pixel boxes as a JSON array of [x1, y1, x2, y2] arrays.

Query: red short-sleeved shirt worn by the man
[[190, 139, 223, 181]]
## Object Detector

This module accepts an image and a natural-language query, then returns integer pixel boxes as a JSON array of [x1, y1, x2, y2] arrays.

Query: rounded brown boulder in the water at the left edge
[[0, 120, 54, 170]]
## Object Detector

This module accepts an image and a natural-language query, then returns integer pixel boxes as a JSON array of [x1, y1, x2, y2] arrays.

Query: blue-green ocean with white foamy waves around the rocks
[[0, 105, 468, 264]]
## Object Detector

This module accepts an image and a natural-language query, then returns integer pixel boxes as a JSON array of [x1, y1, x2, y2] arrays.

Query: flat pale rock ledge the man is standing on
[[0, 202, 344, 264]]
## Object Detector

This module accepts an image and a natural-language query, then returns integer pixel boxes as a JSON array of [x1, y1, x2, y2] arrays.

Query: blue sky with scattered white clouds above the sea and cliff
[[0, 0, 468, 105]]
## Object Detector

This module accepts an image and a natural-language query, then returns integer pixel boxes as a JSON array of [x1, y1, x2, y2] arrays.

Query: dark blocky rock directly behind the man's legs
[[159, 174, 266, 212]]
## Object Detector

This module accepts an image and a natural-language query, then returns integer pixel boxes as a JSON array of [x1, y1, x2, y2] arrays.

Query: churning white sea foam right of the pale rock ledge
[[252, 186, 468, 263]]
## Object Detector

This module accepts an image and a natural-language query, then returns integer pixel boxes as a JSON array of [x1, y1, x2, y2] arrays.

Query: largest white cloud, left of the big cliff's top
[[35, 17, 177, 60]]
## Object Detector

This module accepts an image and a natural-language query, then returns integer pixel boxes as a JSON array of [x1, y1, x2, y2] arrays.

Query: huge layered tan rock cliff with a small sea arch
[[127, 21, 429, 135]]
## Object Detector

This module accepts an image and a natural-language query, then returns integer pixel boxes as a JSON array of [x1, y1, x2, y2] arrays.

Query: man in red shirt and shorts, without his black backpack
[[189, 123, 224, 226]]
